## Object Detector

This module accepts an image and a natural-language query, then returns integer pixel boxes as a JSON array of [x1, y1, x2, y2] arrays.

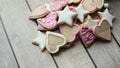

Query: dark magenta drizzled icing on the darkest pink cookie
[[81, 27, 96, 46]]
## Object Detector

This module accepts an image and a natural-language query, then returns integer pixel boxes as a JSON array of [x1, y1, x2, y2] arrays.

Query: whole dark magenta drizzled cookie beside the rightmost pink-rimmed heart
[[80, 24, 96, 47]]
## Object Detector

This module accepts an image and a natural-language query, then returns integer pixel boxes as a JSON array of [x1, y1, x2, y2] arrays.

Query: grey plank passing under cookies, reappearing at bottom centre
[[28, 0, 94, 68]]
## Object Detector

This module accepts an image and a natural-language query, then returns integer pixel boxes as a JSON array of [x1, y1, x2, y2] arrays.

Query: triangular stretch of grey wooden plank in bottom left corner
[[0, 16, 18, 68]]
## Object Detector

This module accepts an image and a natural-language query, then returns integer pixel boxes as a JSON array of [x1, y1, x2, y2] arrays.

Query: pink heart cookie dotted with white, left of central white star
[[37, 12, 57, 29]]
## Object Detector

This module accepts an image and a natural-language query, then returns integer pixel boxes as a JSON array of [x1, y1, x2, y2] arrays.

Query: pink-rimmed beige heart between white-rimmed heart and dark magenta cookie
[[60, 24, 79, 43]]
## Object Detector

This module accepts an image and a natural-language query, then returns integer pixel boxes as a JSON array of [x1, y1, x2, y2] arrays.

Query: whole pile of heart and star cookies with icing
[[29, 0, 115, 54]]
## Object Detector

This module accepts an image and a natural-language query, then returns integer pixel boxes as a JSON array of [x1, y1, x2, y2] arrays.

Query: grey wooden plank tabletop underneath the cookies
[[0, 0, 120, 68]]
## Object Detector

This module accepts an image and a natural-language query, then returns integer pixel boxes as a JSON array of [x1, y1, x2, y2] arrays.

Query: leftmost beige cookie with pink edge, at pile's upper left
[[29, 4, 49, 19]]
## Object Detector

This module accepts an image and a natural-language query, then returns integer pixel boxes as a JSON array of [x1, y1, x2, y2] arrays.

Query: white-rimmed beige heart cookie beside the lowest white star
[[46, 31, 66, 53]]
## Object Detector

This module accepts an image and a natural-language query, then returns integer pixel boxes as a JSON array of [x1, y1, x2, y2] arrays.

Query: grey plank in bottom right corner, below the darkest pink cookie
[[88, 38, 120, 68]]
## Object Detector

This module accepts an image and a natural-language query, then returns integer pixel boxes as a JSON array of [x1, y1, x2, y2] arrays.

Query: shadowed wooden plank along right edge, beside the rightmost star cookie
[[109, 0, 120, 45]]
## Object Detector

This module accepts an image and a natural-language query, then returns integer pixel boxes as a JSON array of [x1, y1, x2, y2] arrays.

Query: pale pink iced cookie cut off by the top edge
[[49, 0, 68, 11]]
